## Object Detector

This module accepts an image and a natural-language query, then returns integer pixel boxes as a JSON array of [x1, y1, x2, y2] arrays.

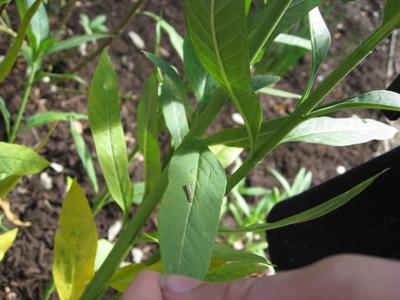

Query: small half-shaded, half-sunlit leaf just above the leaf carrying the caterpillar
[[161, 77, 189, 148]]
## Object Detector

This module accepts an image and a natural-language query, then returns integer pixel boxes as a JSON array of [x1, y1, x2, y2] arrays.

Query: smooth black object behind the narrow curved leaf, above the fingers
[[267, 147, 400, 270]]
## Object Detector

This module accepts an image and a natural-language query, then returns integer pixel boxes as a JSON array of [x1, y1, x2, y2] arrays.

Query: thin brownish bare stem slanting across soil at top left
[[71, 0, 147, 73]]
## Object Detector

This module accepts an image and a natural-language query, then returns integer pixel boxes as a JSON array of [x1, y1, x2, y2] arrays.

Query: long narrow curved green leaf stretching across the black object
[[220, 170, 387, 233]]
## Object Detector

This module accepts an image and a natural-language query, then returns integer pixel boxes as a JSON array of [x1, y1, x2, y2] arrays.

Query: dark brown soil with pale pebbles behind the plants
[[0, 0, 398, 299]]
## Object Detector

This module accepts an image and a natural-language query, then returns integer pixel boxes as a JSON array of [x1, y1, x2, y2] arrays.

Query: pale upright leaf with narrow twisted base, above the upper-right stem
[[303, 7, 331, 99]]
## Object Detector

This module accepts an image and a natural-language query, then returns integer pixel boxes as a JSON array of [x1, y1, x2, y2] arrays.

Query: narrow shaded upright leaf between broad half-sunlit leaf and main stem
[[137, 72, 161, 194]]
